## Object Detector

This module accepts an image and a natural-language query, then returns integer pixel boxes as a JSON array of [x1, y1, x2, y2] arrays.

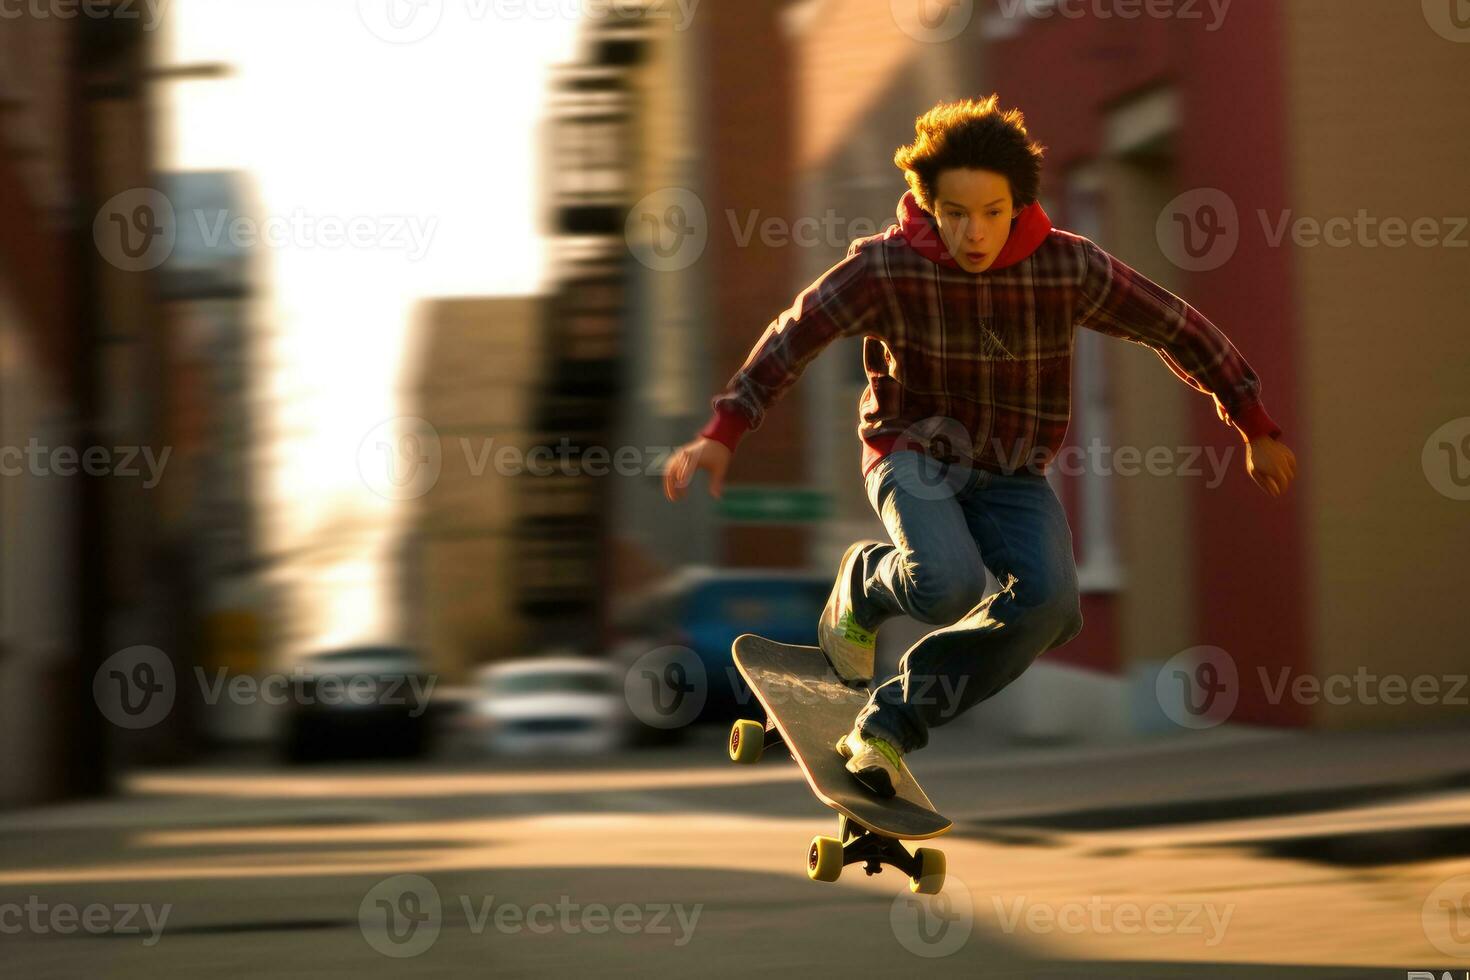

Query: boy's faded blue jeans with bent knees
[[853, 450, 1082, 752]]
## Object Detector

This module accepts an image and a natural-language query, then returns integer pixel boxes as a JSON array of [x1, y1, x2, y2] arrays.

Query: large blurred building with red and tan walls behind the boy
[[791, 0, 1470, 738]]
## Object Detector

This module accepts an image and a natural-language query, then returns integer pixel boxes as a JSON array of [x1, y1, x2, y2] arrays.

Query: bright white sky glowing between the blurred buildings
[[157, 0, 578, 655]]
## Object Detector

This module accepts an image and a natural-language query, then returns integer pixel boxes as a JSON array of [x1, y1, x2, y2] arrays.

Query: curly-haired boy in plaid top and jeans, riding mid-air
[[664, 96, 1297, 795]]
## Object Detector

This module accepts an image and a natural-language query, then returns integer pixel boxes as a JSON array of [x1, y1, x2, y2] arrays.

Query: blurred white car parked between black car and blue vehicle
[[470, 655, 628, 755]]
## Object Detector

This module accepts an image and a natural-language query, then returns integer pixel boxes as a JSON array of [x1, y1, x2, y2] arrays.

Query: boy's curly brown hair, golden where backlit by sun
[[894, 94, 1047, 215]]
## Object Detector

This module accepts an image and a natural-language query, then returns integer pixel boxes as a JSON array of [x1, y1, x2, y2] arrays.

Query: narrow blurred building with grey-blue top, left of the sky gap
[[156, 172, 272, 739]]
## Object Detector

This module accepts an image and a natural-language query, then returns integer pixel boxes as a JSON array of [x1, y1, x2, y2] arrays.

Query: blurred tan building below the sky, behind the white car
[[406, 297, 547, 677]]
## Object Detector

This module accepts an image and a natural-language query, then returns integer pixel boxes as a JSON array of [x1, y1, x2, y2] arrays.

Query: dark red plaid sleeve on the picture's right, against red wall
[[1078, 239, 1282, 439]]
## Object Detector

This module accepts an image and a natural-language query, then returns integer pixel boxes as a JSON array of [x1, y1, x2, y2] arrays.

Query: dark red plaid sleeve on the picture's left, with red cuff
[[700, 242, 879, 450]]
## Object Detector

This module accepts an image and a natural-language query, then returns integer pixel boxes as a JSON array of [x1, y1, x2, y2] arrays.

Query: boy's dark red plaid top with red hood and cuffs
[[701, 192, 1280, 473]]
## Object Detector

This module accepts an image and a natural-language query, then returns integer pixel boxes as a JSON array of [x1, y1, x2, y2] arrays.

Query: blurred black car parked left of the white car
[[284, 646, 432, 763]]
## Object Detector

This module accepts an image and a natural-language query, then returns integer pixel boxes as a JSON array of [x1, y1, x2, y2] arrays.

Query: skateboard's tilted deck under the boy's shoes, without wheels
[[734, 633, 953, 840]]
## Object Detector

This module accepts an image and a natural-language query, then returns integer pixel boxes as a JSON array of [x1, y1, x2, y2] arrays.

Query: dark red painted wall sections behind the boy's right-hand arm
[[986, 3, 1310, 726]]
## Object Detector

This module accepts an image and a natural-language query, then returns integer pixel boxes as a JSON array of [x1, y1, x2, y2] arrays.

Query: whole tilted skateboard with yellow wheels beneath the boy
[[729, 633, 953, 895]]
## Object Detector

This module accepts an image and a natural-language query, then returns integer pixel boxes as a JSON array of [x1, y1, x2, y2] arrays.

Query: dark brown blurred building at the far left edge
[[0, 4, 171, 804]]
